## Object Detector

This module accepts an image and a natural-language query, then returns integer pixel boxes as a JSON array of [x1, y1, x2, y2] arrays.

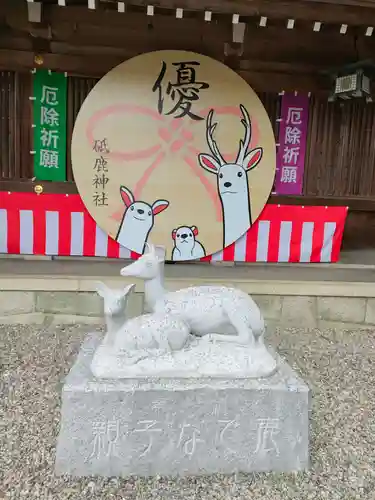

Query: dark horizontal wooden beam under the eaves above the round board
[[48, 6, 375, 64]]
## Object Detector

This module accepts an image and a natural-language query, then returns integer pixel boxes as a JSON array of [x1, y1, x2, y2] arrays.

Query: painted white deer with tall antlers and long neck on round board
[[198, 104, 263, 248]]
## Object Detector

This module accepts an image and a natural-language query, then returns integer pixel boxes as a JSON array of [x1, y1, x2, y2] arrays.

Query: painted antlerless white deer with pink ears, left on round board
[[116, 186, 169, 254]]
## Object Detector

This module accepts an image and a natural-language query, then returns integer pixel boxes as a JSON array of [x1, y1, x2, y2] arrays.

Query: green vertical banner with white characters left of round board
[[33, 69, 67, 181]]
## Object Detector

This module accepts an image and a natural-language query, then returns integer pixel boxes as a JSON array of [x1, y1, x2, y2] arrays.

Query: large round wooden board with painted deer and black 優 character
[[72, 50, 276, 261]]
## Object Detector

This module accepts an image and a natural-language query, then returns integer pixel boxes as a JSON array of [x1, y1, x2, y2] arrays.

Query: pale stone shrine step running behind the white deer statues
[[0, 259, 375, 328]]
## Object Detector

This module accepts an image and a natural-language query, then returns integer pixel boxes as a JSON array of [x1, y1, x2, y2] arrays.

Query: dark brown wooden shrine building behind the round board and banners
[[0, 0, 375, 249]]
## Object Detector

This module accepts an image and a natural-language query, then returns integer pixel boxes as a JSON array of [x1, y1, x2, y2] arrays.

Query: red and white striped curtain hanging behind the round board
[[0, 192, 347, 262]]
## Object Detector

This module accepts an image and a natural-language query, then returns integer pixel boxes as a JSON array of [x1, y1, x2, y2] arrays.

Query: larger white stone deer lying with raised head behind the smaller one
[[121, 244, 265, 345]]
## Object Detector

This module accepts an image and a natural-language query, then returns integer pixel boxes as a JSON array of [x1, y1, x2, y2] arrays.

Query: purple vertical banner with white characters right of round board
[[274, 93, 309, 195]]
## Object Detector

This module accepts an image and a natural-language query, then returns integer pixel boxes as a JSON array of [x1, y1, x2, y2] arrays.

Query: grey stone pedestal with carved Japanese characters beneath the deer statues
[[56, 334, 309, 476]]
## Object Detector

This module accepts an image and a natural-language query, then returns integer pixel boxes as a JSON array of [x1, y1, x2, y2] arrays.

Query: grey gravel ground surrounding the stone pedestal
[[0, 325, 375, 500]]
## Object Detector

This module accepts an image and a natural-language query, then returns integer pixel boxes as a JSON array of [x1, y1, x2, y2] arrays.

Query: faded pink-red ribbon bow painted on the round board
[[86, 104, 259, 222]]
